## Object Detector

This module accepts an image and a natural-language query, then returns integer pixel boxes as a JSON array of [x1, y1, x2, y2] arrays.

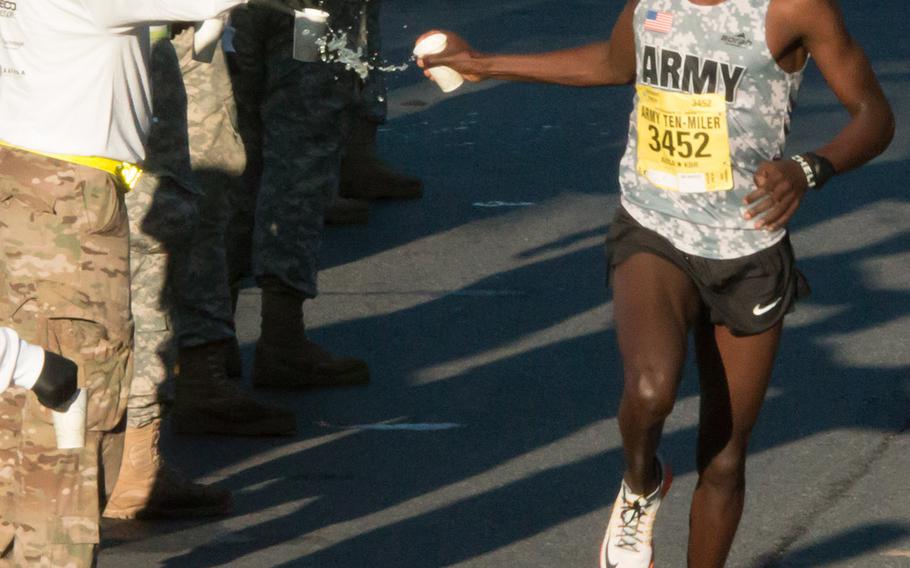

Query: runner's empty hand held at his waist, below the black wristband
[[743, 160, 809, 231]]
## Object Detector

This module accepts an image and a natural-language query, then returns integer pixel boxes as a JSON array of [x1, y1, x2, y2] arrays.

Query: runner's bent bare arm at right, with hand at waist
[[745, 0, 894, 230]]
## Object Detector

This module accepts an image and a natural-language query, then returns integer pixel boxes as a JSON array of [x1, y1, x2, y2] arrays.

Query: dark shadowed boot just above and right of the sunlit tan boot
[[174, 341, 297, 436]]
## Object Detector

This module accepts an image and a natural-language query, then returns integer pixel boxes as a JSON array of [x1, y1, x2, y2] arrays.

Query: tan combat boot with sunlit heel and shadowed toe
[[103, 420, 231, 519]]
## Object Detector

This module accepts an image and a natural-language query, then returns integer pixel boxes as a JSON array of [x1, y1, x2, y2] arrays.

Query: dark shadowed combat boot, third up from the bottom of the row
[[253, 285, 370, 389]]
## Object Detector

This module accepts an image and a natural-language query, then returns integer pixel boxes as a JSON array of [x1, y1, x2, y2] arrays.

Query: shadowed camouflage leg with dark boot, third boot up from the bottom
[[253, 58, 369, 388]]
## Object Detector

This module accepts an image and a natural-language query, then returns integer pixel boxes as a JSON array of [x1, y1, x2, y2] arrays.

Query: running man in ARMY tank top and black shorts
[[418, 0, 894, 568]]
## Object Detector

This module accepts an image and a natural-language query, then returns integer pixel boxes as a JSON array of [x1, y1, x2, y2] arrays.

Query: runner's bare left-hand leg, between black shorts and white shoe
[[613, 253, 701, 495]]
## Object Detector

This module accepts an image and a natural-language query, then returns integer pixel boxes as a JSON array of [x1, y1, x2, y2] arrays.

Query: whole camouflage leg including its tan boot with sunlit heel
[[103, 175, 231, 519]]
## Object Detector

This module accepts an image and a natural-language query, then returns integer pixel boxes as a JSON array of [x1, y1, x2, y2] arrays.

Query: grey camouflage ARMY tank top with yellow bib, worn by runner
[[619, 0, 802, 259]]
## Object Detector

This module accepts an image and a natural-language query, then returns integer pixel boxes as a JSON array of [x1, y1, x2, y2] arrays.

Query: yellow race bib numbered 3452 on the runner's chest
[[636, 85, 733, 193]]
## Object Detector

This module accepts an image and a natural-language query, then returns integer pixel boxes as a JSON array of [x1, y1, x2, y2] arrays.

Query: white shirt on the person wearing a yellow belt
[[0, 0, 247, 162]]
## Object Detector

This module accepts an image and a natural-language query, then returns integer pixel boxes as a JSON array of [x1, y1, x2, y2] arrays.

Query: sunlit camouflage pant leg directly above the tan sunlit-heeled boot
[[125, 173, 173, 428]]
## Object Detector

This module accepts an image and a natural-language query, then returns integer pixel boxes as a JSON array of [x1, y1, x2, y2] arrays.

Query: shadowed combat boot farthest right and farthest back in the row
[[340, 119, 423, 199]]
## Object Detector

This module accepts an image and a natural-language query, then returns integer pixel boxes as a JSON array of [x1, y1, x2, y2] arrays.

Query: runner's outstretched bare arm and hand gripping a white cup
[[417, 0, 638, 87]]
